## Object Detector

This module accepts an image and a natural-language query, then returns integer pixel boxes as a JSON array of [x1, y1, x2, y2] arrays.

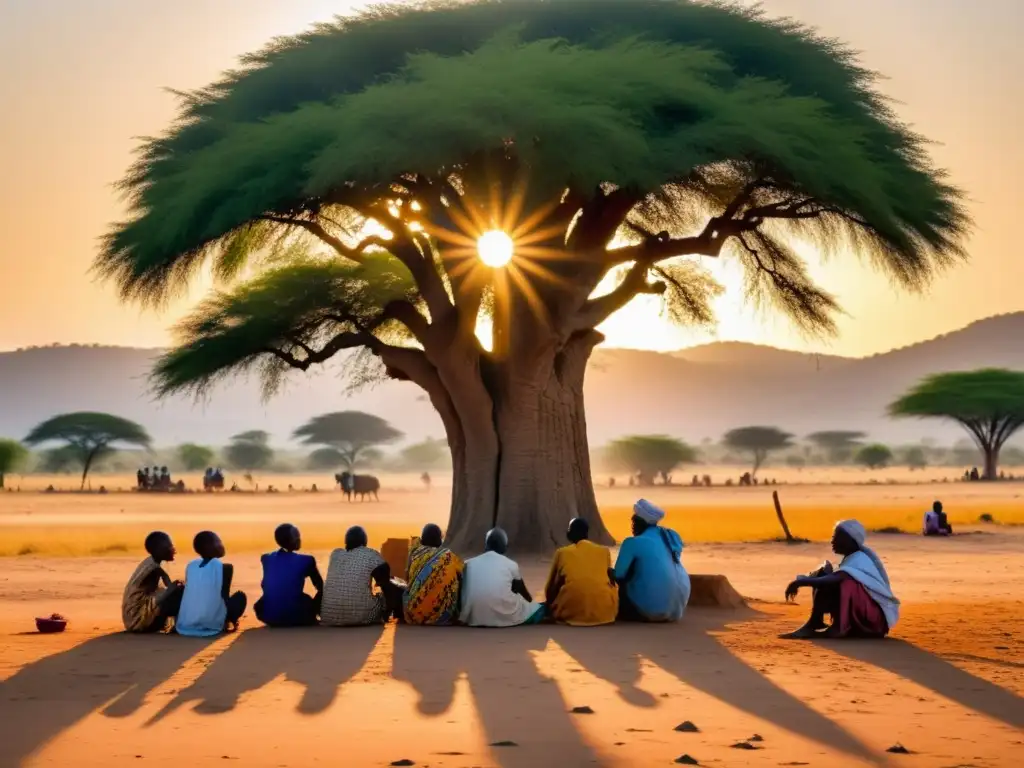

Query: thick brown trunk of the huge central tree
[[445, 333, 612, 554]]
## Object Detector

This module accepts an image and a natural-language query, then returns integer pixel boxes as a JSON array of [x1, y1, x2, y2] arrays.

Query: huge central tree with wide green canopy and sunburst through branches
[[96, 0, 968, 552]]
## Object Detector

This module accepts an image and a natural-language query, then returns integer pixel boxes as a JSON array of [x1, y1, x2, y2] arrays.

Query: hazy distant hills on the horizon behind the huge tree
[[0, 312, 1024, 445]]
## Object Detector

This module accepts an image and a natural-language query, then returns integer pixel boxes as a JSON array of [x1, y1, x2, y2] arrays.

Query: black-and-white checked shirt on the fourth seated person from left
[[321, 547, 387, 627]]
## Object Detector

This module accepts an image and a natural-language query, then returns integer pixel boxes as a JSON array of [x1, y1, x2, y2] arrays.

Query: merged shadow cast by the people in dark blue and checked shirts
[[147, 627, 384, 725]]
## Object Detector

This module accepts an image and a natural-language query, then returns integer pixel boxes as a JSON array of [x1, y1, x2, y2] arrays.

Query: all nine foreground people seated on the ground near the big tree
[[122, 500, 899, 638]]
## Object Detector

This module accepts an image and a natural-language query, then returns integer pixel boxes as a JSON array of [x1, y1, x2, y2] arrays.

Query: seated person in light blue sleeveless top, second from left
[[174, 530, 246, 637]]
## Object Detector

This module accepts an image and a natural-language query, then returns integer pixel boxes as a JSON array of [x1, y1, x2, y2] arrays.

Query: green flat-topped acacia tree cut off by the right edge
[[889, 369, 1024, 480]]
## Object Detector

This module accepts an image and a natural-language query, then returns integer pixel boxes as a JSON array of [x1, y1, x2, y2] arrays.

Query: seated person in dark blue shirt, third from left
[[253, 522, 324, 627]]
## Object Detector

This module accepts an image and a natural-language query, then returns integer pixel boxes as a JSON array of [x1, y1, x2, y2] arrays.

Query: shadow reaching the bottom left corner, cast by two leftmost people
[[0, 634, 211, 765]]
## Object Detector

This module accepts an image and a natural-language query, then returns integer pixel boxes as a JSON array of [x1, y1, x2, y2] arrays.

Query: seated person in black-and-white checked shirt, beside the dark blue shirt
[[321, 525, 401, 627]]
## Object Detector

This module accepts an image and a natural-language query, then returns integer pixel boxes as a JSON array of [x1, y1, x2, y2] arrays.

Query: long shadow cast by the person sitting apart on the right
[[821, 638, 1024, 728]]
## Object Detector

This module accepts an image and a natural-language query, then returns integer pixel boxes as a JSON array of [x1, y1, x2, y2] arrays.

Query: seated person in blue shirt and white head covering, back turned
[[615, 499, 690, 622]]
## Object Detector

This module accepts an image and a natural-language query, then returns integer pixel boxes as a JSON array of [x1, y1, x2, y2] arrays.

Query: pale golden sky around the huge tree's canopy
[[0, 0, 1024, 355]]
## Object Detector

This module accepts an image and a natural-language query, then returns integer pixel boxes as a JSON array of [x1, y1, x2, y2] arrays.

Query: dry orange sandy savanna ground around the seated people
[[0, 471, 1024, 768]]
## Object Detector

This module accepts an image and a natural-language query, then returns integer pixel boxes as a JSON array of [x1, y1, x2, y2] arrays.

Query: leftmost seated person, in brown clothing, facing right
[[121, 530, 182, 633]]
